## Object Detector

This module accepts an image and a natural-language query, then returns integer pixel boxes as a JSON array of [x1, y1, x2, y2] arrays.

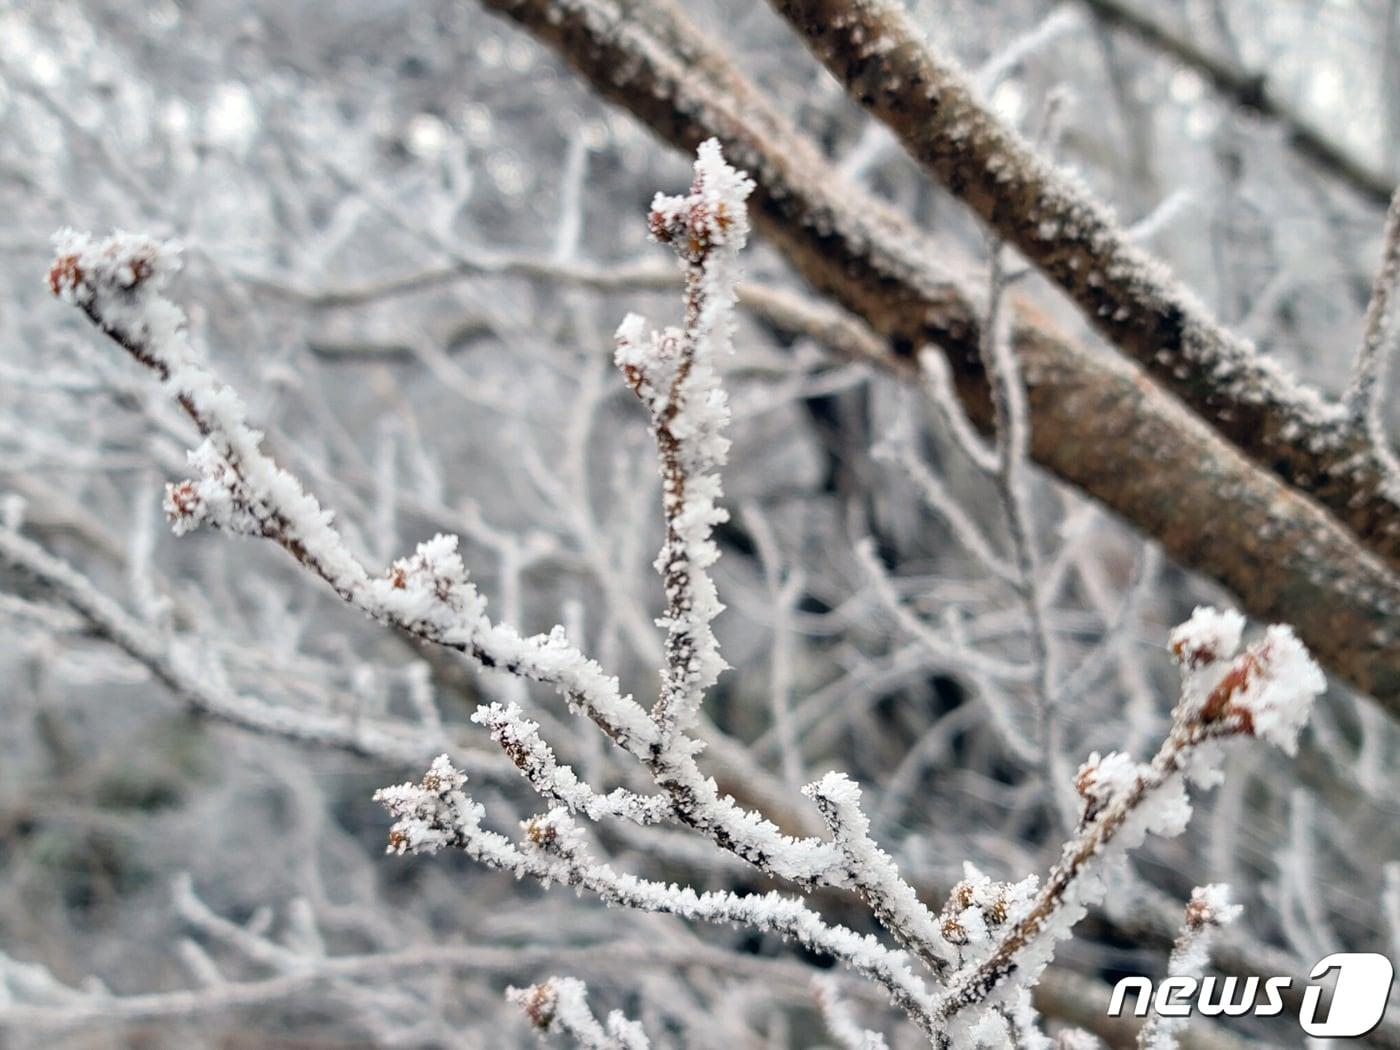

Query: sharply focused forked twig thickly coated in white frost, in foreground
[[49, 141, 1323, 1050]]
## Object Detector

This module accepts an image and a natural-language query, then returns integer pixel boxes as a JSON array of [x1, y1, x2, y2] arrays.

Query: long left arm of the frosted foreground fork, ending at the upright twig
[[49, 231, 655, 753]]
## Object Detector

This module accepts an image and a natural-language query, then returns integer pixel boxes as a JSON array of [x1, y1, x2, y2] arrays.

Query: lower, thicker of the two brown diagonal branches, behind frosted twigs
[[483, 0, 1400, 714]]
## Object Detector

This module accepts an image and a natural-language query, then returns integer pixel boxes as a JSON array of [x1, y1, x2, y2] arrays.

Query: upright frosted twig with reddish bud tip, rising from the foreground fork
[[616, 139, 753, 736]]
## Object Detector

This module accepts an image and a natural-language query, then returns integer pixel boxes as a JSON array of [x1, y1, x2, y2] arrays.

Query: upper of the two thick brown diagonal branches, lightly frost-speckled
[[774, 0, 1400, 567]]
